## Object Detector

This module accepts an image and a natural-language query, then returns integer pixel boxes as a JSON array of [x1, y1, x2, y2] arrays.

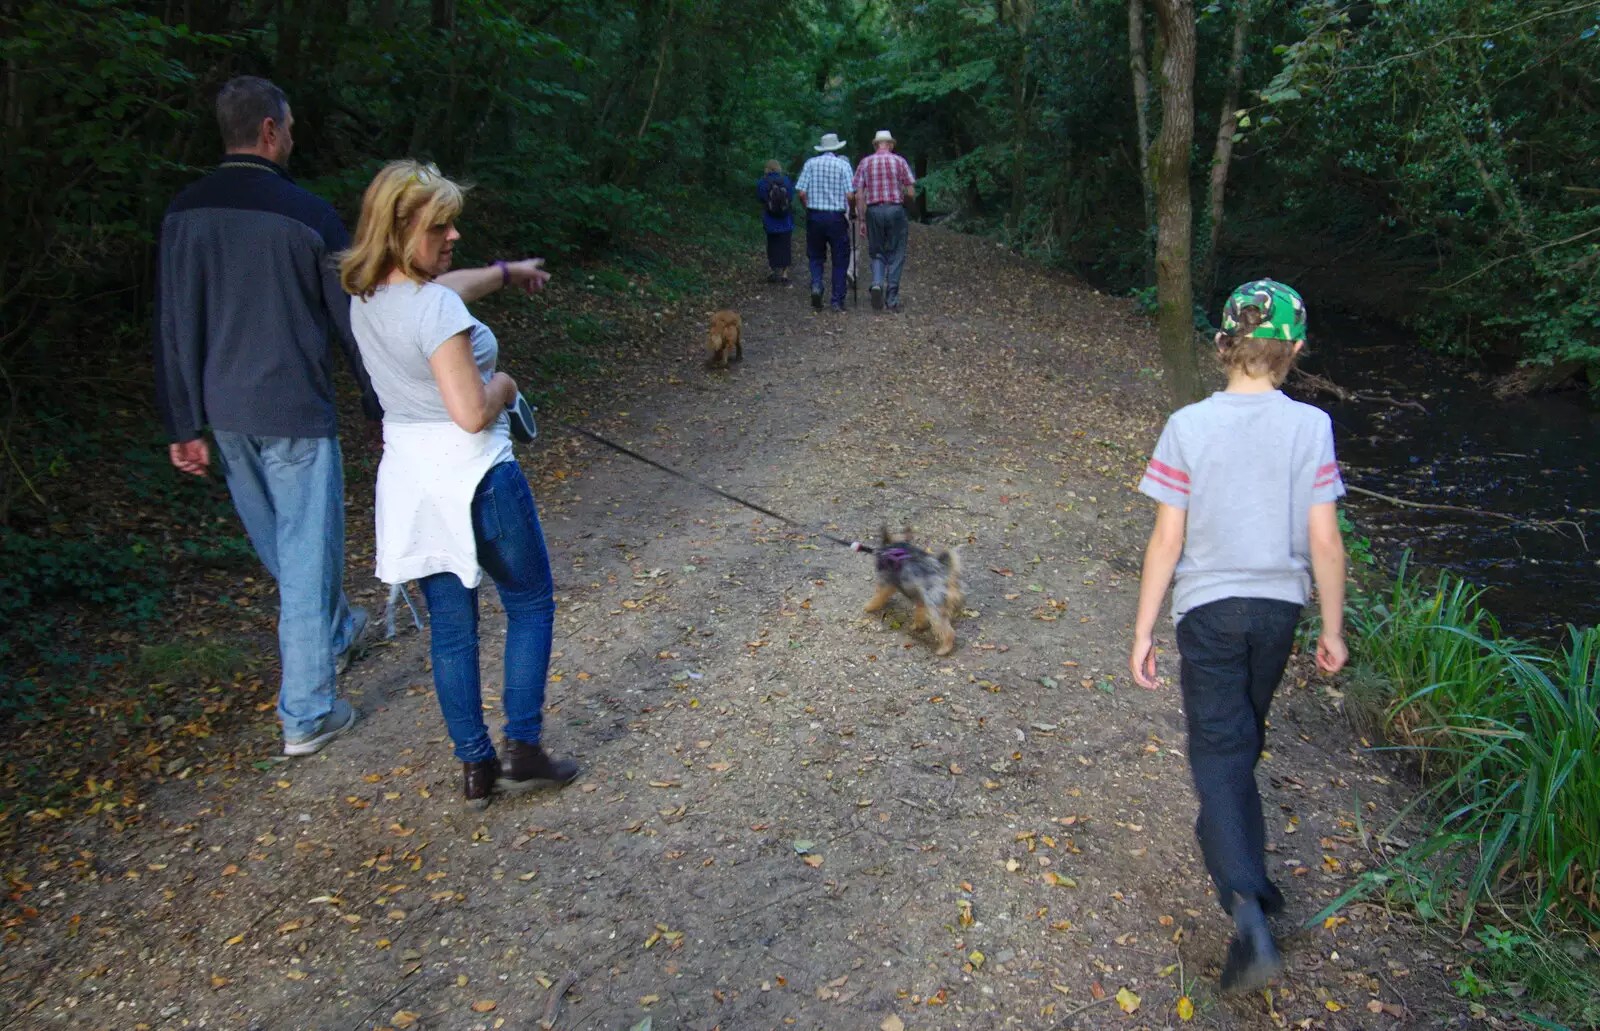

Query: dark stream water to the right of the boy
[[1286, 315, 1600, 640]]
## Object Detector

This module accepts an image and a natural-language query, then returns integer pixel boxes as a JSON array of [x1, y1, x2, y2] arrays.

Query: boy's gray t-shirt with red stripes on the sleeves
[[1139, 391, 1344, 621]]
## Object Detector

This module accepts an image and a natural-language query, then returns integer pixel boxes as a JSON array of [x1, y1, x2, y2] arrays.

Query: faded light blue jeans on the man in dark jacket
[[213, 429, 355, 738]]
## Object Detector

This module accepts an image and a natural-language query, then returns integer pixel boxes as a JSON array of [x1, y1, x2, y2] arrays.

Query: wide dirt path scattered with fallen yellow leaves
[[0, 229, 1461, 1031]]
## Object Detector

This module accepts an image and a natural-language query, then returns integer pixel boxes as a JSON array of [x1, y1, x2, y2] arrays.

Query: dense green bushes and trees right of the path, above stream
[[830, 0, 1600, 381]]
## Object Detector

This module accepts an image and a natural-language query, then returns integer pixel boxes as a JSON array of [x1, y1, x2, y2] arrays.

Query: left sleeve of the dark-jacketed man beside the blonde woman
[[155, 212, 205, 443]]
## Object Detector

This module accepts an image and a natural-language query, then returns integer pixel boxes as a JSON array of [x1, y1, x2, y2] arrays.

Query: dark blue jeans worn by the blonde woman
[[421, 461, 555, 762]]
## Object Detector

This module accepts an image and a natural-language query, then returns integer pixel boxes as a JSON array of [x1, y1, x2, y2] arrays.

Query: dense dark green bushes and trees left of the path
[[0, 0, 814, 691]]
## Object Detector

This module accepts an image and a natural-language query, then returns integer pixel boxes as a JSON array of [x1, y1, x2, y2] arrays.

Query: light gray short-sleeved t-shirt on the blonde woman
[[350, 283, 506, 423]]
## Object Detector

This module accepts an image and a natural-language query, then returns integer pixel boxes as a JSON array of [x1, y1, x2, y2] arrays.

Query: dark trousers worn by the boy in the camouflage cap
[[1178, 597, 1301, 913]]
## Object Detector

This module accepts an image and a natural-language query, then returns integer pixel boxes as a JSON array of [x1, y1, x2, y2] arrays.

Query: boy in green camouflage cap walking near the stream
[[1128, 279, 1346, 991]]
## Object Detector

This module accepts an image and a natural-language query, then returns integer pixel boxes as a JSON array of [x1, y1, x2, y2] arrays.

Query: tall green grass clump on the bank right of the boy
[[1350, 567, 1600, 930]]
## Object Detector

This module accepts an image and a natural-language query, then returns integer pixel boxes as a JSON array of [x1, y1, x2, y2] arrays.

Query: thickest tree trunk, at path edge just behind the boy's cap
[[1155, 0, 1200, 405]]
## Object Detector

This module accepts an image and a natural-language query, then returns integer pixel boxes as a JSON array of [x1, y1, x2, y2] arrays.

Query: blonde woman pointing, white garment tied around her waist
[[339, 162, 578, 807]]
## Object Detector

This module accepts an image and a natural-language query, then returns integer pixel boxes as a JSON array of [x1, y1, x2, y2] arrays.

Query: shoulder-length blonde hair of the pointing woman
[[339, 160, 469, 298]]
